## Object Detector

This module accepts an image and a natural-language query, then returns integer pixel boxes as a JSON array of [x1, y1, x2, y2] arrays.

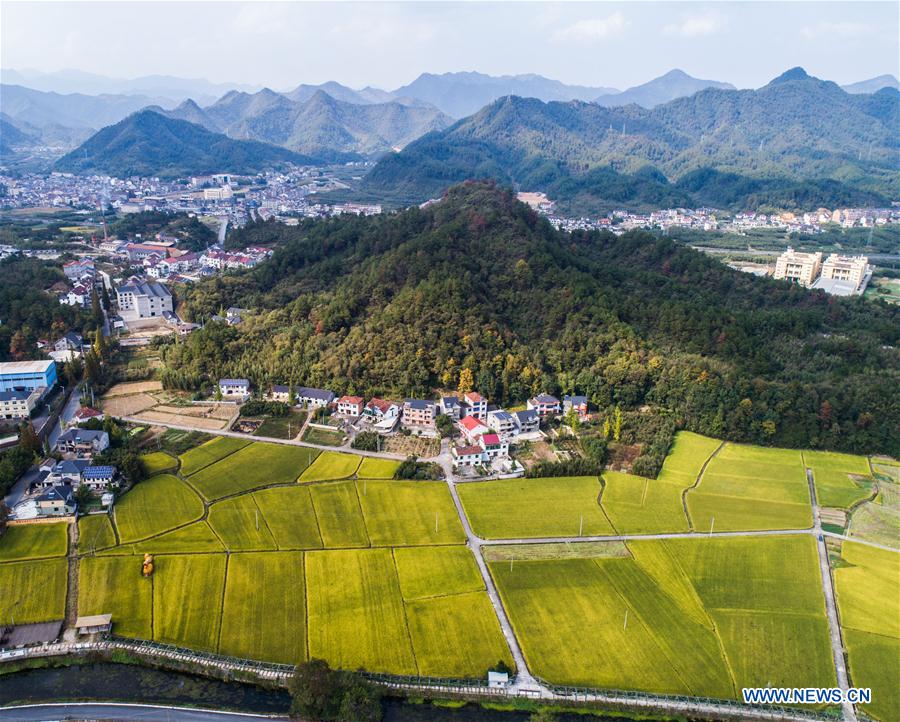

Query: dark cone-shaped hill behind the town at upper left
[[53, 110, 314, 177]]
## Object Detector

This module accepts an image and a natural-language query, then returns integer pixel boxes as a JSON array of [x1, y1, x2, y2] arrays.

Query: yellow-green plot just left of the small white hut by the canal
[[406, 591, 514, 678]]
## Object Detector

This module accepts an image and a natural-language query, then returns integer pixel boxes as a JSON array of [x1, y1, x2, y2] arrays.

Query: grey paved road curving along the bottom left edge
[[0, 702, 288, 722]]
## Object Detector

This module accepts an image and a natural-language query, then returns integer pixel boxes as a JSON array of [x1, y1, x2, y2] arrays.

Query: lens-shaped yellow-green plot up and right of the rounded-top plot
[[191, 442, 318, 501]]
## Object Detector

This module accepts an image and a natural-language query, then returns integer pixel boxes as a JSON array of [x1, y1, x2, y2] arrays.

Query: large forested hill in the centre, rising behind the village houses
[[171, 183, 900, 455]]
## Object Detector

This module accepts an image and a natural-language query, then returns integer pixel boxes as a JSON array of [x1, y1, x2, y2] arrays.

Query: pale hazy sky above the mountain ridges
[[0, 0, 900, 90]]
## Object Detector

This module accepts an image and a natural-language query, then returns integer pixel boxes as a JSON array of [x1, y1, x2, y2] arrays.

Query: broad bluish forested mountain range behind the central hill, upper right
[[363, 68, 900, 212]]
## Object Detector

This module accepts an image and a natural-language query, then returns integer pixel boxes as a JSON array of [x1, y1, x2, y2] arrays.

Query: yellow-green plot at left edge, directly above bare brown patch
[[0, 559, 68, 625]]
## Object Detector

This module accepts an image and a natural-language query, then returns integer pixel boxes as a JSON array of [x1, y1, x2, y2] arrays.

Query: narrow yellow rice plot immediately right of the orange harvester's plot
[[153, 554, 225, 651]]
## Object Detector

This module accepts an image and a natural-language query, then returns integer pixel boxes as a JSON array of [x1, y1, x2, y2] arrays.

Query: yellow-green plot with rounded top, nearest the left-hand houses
[[114, 474, 203, 542]]
